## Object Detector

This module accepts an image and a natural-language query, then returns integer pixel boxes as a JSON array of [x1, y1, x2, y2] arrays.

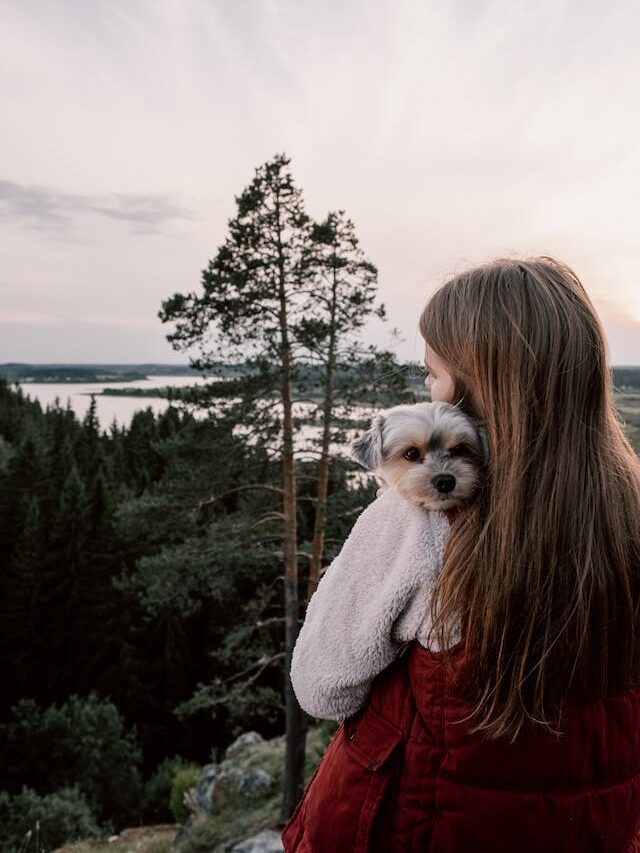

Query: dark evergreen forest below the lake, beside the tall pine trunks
[[0, 380, 410, 849]]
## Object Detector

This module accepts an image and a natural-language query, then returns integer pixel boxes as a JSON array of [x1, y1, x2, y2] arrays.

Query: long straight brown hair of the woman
[[420, 257, 640, 738]]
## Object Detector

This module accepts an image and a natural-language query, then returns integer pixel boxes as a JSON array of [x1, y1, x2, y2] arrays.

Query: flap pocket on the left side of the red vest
[[283, 708, 402, 853]]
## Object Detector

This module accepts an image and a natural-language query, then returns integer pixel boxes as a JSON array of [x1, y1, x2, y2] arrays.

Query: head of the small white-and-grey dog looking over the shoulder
[[351, 402, 486, 510]]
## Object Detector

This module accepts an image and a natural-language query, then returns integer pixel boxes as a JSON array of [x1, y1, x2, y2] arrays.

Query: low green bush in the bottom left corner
[[0, 787, 99, 853]]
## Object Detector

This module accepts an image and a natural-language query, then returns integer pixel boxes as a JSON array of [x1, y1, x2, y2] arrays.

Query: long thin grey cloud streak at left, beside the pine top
[[0, 181, 196, 232]]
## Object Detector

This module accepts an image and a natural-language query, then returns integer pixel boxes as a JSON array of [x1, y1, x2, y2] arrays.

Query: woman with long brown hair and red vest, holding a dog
[[283, 258, 640, 853]]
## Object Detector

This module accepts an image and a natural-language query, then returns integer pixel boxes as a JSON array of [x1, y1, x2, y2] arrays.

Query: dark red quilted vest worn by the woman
[[282, 642, 640, 853]]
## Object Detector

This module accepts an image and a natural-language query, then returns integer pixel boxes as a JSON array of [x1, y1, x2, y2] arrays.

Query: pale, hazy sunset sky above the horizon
[[0, 0, 640, 364]]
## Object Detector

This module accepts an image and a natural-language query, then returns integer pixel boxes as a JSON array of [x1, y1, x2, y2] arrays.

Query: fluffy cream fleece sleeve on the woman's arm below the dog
[[291, 488, 449, 720]]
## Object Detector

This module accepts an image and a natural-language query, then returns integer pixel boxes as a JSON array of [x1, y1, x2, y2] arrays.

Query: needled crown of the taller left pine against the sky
[[160, 155, 310, 374]]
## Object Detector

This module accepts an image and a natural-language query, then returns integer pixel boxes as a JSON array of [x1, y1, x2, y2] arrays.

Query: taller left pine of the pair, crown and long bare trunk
[[160, 155, 313, 820]]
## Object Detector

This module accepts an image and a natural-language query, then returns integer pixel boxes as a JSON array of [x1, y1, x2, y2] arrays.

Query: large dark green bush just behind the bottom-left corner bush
[[0, 693, 142, 826]]
